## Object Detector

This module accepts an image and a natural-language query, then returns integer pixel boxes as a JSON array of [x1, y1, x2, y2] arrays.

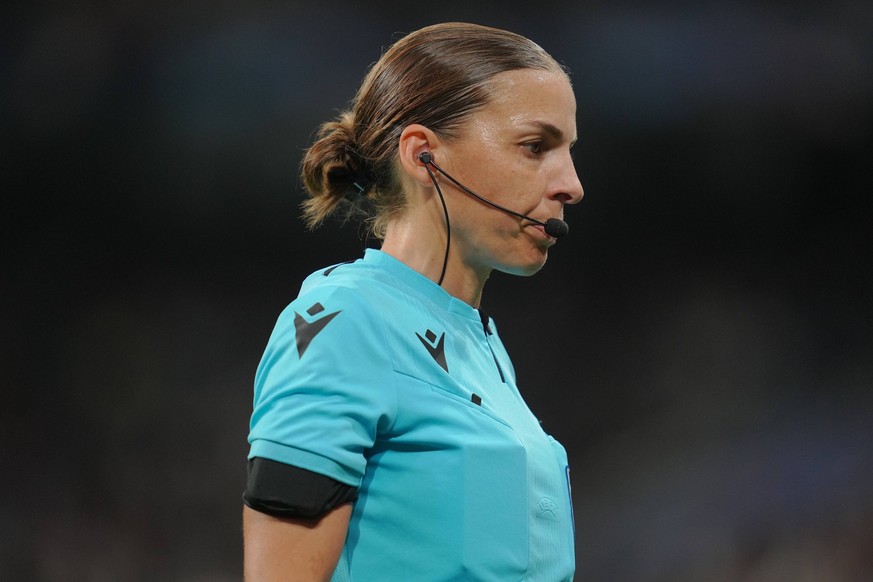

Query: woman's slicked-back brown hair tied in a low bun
[[301, 23, 565, 238]]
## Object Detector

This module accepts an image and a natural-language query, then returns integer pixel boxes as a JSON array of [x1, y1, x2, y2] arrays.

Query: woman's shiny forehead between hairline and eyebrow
[[472, 69, 576, 140]]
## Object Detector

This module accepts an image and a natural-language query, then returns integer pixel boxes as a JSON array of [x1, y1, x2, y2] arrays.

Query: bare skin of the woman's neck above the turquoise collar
[[381, 194, 491, 309]]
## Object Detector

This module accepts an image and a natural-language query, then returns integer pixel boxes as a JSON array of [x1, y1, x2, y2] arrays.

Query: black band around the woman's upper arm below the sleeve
[[243, 457, 358, 519]]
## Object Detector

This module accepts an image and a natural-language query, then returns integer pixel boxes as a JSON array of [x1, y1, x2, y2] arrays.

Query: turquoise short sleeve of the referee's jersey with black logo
[[249, 286, 397, 487]]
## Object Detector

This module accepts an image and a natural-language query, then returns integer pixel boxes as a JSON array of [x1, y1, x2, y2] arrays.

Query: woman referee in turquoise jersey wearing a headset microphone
[[243, 23, 583, 582]]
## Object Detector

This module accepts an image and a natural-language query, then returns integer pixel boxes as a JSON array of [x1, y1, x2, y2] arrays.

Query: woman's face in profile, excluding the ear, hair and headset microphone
[[441, 69, 583, 276]]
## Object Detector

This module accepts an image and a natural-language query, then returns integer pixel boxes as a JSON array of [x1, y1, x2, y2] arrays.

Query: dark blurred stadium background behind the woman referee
[[0, 0, 873, 582]]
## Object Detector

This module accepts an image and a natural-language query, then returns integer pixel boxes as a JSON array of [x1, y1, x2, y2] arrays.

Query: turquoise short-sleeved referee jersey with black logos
[[249, 249, 575, 582]]
